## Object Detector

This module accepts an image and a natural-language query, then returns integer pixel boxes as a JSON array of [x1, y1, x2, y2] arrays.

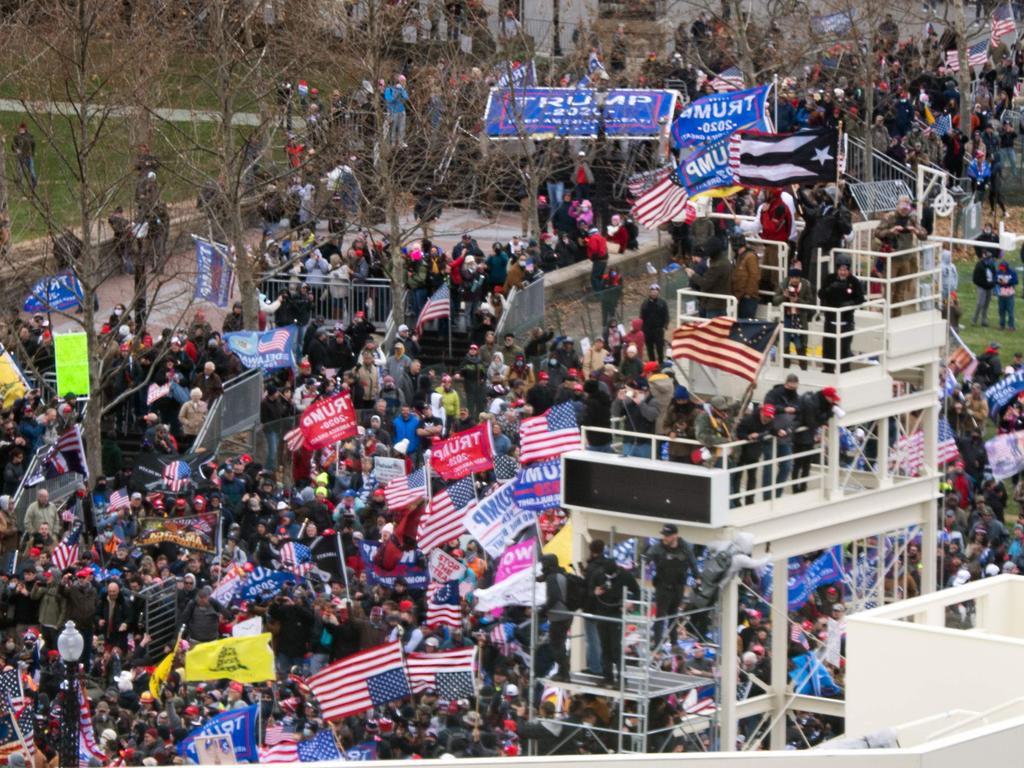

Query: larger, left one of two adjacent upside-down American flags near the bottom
[[306, 641, 412, 720]]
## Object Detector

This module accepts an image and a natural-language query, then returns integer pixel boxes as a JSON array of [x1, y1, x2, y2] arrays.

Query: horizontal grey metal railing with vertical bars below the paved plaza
[[260, 273, 392, 326]]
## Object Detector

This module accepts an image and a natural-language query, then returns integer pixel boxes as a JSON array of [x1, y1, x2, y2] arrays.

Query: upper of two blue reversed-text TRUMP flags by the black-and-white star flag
[[672, 85, 772, 146]]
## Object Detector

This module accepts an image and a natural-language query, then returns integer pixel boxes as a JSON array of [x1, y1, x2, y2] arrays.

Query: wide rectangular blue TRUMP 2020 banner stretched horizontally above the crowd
[[484, 88, 677, 138]]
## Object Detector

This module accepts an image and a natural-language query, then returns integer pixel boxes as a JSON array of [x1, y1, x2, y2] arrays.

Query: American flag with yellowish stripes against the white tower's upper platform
[[672, 317, 776, 381]]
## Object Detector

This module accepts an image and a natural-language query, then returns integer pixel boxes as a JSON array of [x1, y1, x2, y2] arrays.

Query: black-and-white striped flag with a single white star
[[729, 128, 839, 186]]
